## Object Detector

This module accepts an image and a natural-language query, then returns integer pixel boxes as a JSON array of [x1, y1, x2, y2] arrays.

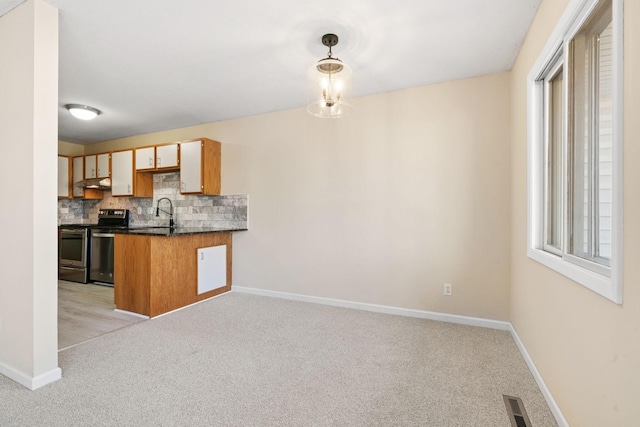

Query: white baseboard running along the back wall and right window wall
[[231, 286, 569, 427]]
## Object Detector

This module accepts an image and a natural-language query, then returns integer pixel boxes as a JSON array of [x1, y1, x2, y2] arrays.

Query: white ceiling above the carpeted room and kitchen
[[0, 0, 541, 144]]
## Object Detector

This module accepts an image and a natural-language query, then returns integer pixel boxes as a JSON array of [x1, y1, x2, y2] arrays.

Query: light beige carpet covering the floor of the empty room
[[0, 293, 556, 427]]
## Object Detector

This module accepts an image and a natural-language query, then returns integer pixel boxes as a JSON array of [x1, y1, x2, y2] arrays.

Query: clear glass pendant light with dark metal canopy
[[307, 34, 353, 118]]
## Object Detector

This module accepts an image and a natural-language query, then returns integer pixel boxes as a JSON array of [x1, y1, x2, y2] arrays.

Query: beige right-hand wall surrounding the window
[[511, 0, 640, 426]]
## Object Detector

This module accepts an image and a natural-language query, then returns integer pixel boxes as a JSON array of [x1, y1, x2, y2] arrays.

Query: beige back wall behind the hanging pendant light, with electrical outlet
[[95, 73, 510, 320]]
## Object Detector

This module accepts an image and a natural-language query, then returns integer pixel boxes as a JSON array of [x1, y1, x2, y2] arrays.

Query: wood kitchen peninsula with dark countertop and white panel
[[114, 227, 245, 317]]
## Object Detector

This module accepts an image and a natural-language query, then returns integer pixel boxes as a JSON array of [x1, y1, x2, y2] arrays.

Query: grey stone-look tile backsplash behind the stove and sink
[[58, 172, 248, 228]]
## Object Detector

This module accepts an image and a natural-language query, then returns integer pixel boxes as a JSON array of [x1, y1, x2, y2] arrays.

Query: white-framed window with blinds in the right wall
[[527, 0, 622, 303]]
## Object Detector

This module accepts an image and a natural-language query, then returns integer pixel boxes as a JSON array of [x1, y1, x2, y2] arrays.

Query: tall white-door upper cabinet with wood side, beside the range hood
[[111, 150, 153, 197]]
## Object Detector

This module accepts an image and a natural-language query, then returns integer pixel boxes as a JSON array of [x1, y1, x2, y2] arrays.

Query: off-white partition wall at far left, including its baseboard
[[0, 0, 60, 388]]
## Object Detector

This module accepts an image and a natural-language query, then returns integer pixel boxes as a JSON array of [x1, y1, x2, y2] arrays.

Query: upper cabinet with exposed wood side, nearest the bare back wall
[[180, 138, 222, 196]]
